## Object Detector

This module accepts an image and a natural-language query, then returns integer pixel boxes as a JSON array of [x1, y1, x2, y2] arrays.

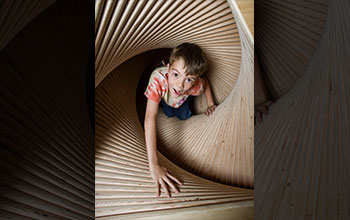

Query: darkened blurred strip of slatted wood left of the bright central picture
[[0, 1, 94, 220]]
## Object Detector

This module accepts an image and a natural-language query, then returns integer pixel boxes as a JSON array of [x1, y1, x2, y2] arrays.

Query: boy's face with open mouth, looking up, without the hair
[[167, 59, 198, 98]]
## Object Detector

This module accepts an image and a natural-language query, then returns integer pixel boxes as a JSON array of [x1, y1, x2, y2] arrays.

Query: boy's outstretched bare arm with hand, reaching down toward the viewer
[[145, 99, 182, 197]]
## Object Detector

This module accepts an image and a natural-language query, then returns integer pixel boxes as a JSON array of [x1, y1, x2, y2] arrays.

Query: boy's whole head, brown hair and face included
[[168, 43, 207, 98]]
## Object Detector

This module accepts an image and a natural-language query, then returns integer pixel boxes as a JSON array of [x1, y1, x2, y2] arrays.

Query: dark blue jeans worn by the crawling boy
[[161, 96, 192, 120]]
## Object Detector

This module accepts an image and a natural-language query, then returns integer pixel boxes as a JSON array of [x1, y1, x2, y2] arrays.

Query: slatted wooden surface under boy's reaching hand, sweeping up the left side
[[95, 51, 253, 219]]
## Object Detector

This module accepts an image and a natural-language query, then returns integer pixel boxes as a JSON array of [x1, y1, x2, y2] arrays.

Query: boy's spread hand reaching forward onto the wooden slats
[[150, 165, 183, 198]]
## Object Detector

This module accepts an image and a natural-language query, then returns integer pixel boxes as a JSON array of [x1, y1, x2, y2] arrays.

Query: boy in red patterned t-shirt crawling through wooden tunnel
[[144, 43, 216, 197]]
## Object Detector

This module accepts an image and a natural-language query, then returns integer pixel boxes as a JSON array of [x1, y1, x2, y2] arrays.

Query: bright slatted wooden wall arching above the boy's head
[[95, 0, 241, 103]]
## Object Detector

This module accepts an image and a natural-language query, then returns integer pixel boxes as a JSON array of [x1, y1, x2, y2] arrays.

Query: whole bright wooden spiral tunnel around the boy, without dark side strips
[[95, 0, 254, 219]]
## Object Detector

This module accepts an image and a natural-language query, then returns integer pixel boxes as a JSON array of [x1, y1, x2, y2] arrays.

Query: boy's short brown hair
[[169, 43, 208, 76]]
